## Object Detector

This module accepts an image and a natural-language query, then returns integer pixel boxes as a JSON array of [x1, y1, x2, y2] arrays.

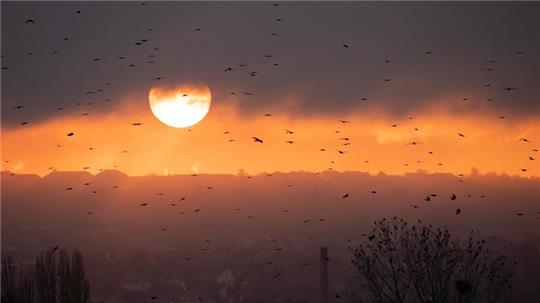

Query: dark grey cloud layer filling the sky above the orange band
[[2, 2, 540, 126]]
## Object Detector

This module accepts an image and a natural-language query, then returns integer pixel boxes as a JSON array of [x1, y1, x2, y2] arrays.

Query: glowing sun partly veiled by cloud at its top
[[148, 85, 212, 128]]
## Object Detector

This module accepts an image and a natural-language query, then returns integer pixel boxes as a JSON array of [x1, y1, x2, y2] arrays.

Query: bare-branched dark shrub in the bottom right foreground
[[350, 217, 514, 303]]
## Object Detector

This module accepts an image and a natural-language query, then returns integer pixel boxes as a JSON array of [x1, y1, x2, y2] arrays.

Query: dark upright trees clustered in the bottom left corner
[[2, 247, 90, 303]]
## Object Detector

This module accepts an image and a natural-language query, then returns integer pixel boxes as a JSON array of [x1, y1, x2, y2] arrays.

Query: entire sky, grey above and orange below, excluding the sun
[[1, 2, 540, 177]]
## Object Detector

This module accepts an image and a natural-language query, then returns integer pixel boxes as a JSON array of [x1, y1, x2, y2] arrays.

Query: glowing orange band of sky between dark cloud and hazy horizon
[[2, 92, 540, 176]]
